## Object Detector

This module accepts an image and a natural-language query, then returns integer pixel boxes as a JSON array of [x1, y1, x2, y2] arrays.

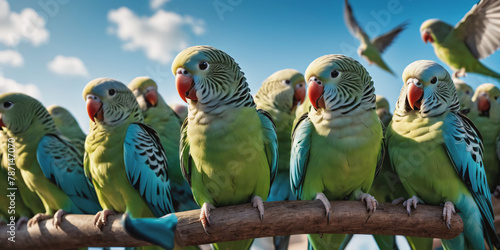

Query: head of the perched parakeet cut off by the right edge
[[471, 83, 500, 124]]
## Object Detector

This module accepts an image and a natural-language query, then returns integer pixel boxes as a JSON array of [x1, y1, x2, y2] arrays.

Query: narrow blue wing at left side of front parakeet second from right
[[290, 113, 313, 200]]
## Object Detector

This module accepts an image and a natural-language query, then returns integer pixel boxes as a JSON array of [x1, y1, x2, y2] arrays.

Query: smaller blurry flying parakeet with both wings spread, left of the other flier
[[344, 0, 407, 75]]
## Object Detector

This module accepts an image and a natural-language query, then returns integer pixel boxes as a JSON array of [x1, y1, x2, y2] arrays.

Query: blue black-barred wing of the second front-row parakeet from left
[[123, 123, 174, 217]]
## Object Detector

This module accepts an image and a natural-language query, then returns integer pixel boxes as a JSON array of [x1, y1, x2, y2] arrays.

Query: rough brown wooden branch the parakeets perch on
[[0, 201, 463, 249]]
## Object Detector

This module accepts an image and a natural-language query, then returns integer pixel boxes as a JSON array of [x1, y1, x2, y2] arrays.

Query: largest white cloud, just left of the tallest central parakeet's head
[[108, 7, 205, 64]]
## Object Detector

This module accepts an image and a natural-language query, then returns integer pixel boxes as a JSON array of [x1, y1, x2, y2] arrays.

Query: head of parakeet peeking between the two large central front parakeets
[[255, 69, 306, 112]]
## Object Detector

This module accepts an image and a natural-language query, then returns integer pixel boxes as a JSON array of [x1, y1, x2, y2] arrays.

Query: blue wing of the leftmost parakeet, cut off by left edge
[[36, 134, 101, 214]]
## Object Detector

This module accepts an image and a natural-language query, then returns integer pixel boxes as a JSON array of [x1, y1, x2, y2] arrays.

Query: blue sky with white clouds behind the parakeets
[[0, 0, 500, 131]]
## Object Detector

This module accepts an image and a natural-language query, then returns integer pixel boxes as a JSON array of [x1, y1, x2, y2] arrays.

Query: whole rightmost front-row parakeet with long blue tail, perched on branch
[[386, 60, 500, 249]]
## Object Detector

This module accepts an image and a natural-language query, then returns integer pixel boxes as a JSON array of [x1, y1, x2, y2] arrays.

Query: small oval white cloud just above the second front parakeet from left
[[47, 55, 89, 76]]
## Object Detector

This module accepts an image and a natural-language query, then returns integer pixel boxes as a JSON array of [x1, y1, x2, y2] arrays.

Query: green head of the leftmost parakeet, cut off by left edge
[[0, 93, 57, 134]]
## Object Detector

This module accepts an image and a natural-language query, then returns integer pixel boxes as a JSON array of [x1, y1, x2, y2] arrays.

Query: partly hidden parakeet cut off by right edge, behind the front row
[[469, 83, 500, 192]]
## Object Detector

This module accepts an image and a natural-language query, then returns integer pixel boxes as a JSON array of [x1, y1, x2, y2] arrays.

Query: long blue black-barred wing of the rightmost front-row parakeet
[[443, 112, 500, 248]]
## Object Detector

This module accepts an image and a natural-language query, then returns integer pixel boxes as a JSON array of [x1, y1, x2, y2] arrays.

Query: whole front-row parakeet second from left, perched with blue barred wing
[[83, 78, 174, 236]]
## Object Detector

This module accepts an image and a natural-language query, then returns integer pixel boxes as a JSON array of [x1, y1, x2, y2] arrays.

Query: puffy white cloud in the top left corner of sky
[[0, 0, 49, 47]]
